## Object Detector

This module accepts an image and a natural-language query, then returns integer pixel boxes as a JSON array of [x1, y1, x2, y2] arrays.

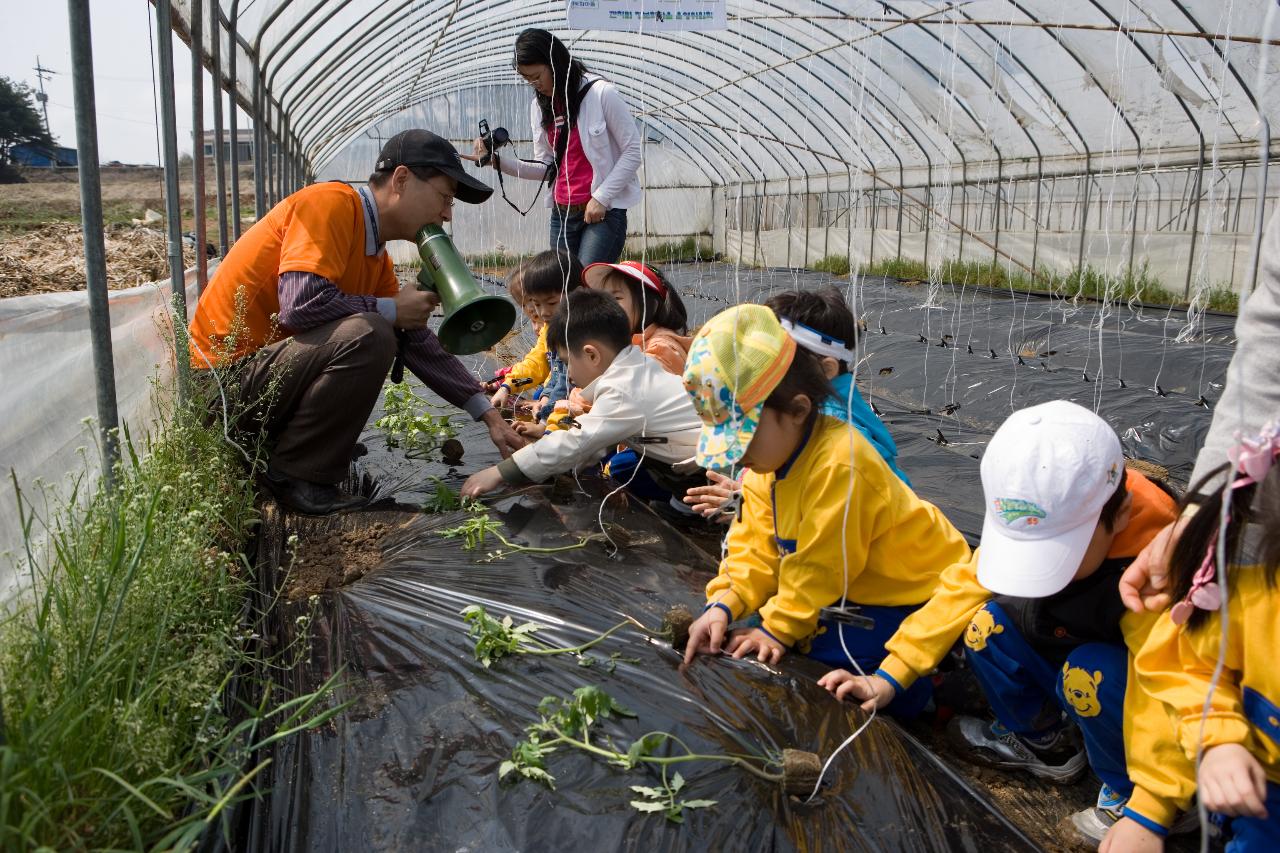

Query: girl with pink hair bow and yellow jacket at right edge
[[1121, 424, 1280, 853]]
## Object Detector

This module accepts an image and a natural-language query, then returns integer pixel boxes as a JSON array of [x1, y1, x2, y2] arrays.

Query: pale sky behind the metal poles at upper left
[[0, 0, 248, 164]]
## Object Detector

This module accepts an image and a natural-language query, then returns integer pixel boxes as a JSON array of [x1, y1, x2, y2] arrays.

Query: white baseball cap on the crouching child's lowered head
[[978, 400, 1125, 598]]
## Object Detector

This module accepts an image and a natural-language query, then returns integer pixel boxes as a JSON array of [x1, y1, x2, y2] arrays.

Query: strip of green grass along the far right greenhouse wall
[[812, 255, 1239, 313]]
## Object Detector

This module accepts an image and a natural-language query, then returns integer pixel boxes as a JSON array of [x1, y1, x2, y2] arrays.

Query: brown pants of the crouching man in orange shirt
[[239, 314, 396, 483]]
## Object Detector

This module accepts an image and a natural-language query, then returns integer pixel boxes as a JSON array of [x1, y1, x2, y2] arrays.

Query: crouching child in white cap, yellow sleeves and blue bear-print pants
[[820, 400, 1193, 843]]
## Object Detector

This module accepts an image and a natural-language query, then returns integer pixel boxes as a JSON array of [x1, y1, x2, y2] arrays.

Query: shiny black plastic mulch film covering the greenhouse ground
[[239, 265, 1233, 850]]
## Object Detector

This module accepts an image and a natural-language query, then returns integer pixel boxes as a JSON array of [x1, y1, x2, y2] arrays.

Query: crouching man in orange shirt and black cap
[[188, 129, 525, 515]]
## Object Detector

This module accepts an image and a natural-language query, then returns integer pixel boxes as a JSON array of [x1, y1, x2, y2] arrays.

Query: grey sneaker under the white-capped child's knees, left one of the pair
[[947, 716, 1089, 783]]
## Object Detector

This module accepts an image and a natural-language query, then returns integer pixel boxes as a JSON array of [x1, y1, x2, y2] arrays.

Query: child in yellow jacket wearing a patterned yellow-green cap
[[685, 305, 977, 716]]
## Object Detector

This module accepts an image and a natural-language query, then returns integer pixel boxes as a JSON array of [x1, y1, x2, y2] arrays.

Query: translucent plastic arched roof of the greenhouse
[[185, 0, 1277, 183]]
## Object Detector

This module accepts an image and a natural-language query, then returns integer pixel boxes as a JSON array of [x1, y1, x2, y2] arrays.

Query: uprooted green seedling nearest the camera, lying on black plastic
[[498, 686, 820, 822]]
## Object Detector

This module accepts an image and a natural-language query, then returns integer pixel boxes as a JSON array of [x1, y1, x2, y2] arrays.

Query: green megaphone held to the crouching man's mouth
[[417, 225, 516, 355]]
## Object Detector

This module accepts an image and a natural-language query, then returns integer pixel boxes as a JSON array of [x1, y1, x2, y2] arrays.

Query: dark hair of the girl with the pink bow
[[1169, 465, 1280, 628]]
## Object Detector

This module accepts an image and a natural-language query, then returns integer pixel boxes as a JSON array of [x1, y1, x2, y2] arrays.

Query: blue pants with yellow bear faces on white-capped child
[[964, 601, 1133, 797]]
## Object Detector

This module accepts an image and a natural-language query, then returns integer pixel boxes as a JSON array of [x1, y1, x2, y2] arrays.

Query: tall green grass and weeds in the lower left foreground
[[0, 368, 345, 849]]
